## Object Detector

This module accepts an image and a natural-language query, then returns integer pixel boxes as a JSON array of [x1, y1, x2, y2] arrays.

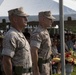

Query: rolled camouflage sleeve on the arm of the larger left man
[[2, 33, 16, 58]]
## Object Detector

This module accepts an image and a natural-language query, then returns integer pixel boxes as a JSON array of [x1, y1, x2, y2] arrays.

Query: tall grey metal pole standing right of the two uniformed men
[[59, 0, 65, 75]]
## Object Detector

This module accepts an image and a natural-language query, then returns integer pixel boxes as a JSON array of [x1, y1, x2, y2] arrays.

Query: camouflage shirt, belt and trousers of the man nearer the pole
[[30, 26, 51, 75]]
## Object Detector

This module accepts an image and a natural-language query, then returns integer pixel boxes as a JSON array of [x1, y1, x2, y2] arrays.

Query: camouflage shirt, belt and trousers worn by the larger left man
[[2, 28, 32, 75]]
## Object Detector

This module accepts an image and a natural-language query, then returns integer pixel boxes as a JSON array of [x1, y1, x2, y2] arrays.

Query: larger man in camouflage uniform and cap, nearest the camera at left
[[2, 7, 32, 75]]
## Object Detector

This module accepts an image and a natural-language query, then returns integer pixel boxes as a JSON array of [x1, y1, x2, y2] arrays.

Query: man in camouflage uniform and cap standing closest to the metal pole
[[30, 11, 55, 75]]
